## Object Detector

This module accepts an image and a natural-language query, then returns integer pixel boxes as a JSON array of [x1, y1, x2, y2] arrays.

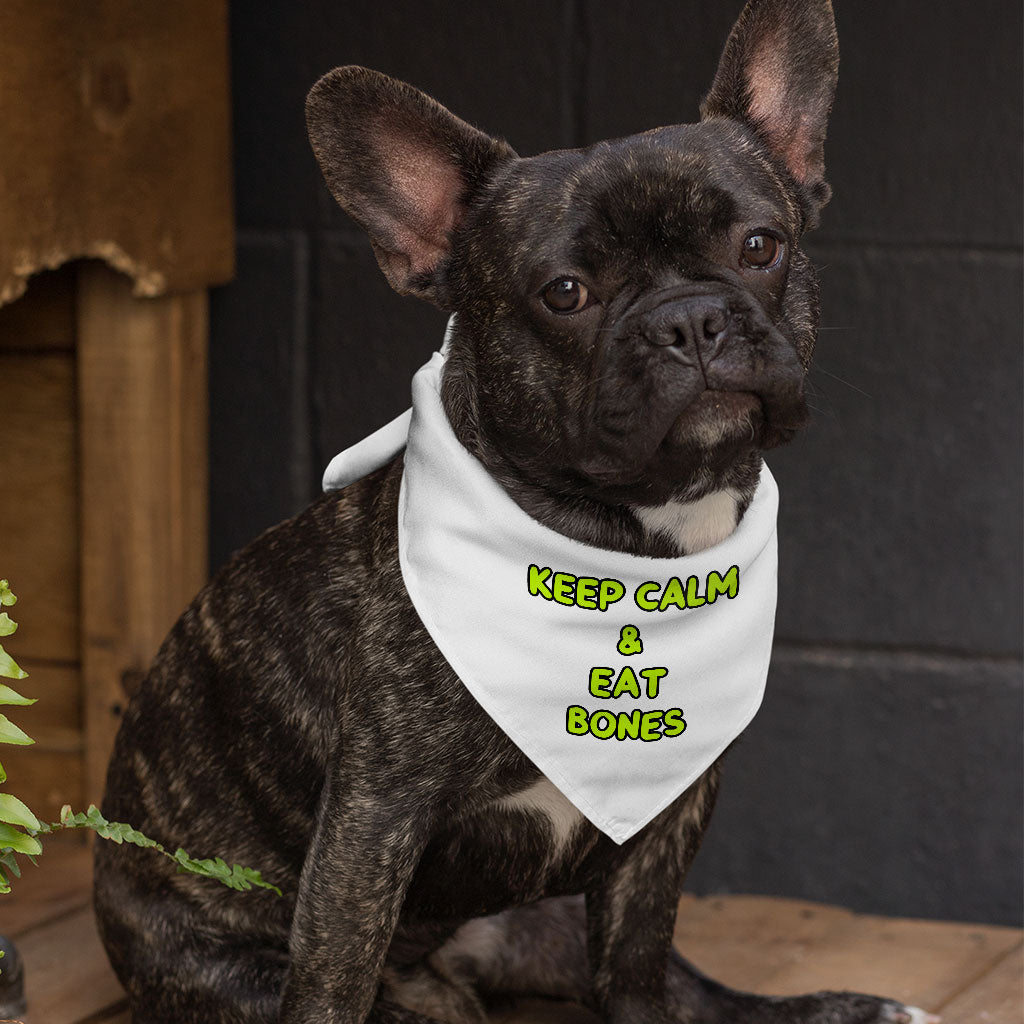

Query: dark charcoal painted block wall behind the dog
[[211, 0, 1022, 923]]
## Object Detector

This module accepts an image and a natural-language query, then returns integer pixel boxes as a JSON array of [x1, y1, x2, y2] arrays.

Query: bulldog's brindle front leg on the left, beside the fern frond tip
[[281, 758, 431, 1024]]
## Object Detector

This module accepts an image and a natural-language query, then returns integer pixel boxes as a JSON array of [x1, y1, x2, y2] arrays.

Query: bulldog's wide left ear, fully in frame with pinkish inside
[[306, 67, 515, 305]]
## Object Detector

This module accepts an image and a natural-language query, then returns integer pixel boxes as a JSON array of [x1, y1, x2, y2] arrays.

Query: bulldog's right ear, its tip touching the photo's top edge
[[700, 0, 839, 226]]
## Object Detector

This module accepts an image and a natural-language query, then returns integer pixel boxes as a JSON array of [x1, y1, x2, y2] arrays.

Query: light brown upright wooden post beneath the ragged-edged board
[[78, 263, 208, 803]]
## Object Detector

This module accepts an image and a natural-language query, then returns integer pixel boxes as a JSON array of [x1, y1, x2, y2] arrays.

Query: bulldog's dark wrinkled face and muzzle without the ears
[[446, 121, 814, 501]]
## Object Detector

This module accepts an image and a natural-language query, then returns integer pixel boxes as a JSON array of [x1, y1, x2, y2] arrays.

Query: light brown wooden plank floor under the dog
[[0, 840, 1024, 1024]]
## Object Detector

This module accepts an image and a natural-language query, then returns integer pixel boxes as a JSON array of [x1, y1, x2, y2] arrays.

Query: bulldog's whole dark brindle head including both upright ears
[[306, 0, 839, 505]]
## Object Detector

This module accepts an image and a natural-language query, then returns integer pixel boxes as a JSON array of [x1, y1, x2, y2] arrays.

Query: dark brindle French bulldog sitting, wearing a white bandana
[[95, 0, 935, 1024]]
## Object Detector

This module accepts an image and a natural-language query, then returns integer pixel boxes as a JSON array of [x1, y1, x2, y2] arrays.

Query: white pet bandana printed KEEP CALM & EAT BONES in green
[[324, 325, 778, 843]]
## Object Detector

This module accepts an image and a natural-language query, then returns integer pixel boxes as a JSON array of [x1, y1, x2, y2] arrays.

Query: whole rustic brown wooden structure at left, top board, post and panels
[[0, 0, 228, 831]]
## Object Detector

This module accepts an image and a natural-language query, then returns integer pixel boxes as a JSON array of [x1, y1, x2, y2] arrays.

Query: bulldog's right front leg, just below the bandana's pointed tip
[[587, 764, 719, 1024]]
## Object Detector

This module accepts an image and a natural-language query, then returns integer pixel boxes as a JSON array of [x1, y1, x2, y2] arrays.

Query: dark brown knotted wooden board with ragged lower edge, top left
[[0, 0, 233, 305]]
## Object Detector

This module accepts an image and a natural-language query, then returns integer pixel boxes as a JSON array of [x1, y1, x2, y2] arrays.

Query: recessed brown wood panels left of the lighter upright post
[[0, 288, 84, 819]]
